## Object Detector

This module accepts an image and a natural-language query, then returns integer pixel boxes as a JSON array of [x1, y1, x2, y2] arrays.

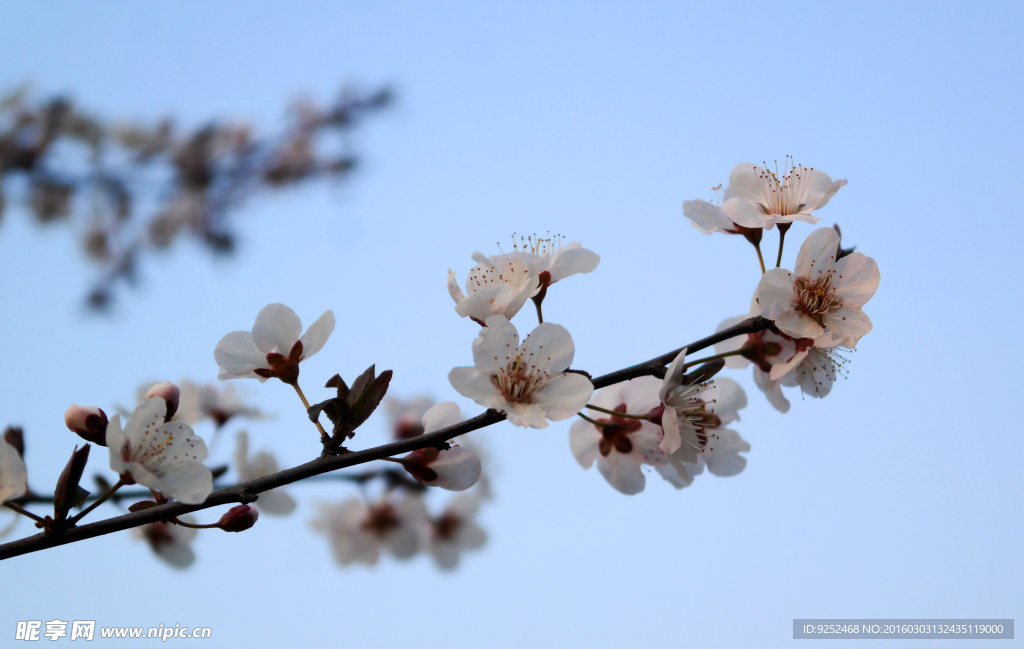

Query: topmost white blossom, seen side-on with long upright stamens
[[722, 159, 847, 229]]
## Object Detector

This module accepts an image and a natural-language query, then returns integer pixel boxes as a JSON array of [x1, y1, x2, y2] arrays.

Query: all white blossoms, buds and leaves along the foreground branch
[[0, 158, 880, 569]]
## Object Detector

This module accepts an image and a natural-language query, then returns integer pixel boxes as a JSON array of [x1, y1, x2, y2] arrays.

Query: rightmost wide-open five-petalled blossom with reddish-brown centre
[[758, 227, 881, 348]]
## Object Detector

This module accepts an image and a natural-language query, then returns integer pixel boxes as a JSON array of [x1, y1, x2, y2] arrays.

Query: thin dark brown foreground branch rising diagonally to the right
[[0, 317, 771, 560]]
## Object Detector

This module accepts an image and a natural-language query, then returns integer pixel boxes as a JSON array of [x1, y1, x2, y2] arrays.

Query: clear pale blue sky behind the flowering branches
[[0, 2, 1024, 649]]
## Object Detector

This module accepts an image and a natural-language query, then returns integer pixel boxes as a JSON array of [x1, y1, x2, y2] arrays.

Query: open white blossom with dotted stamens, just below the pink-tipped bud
[[106, 397, 213, 505]]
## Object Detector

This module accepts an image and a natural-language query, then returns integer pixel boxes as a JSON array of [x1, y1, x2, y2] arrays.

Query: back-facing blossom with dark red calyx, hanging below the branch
[[569, 377, 668, 495]]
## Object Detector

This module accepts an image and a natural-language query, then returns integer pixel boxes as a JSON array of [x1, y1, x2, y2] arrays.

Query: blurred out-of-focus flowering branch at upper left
[[0, 84, 393, 310]]
